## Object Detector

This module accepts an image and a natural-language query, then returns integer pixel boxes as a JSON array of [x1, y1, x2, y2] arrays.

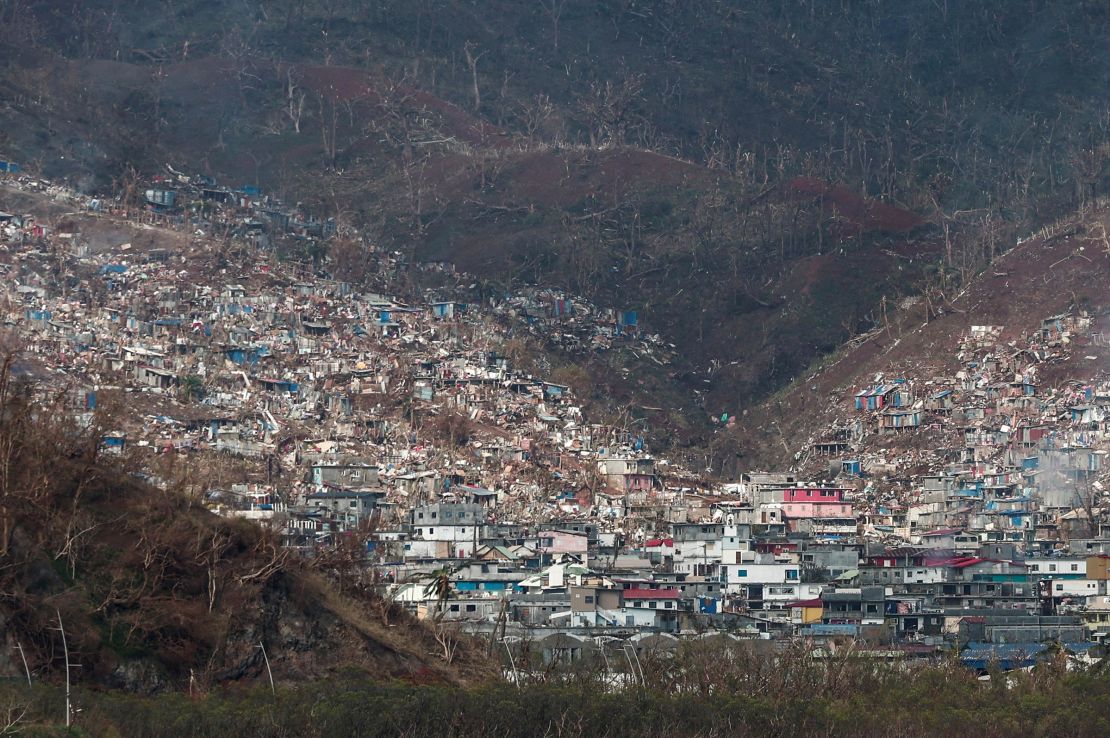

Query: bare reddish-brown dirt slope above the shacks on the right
[[734, 209, 1110, 465]]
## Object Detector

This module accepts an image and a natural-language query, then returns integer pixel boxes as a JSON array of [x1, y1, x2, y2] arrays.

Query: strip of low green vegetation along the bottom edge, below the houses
[[0, 661, 1110, 738]]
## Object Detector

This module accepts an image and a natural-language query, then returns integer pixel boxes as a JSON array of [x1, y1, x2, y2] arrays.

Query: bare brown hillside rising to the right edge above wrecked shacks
[[720, 201, 1110, 466]]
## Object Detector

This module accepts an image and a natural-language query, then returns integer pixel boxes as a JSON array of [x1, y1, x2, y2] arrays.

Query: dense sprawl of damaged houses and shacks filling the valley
[[0, 171, 1110, 668]]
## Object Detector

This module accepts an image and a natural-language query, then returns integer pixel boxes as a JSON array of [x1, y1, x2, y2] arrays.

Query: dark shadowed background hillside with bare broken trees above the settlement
[[0, 0, 1110, 461]]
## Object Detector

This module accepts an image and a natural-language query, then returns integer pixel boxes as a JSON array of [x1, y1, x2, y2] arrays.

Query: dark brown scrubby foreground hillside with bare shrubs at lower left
[[0, 354, 493, 692]]
